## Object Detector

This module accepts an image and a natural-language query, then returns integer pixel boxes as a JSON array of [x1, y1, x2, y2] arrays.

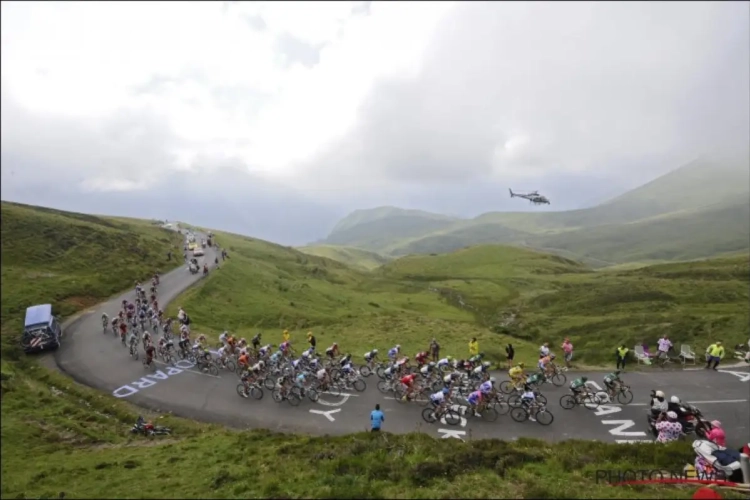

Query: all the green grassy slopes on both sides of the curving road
[[0, 202, 750, 498]]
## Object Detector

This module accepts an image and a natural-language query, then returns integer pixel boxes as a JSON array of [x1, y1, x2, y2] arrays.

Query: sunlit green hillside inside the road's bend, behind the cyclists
[[171, 235, 750, 365]]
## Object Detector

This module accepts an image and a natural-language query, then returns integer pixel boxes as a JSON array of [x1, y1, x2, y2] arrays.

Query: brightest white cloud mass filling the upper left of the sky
[[2, 2, 451, 186]]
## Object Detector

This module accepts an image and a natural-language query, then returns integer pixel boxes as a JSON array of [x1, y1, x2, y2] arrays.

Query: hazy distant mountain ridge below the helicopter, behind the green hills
[[324, 160, 750, 267]]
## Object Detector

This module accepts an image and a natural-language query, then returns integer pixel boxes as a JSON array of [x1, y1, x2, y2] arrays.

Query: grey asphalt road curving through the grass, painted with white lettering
[[55, 235, 750, 445]]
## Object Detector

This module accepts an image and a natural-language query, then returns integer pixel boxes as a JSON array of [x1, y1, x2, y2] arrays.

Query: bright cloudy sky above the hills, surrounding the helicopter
[[0, 2, 750, 245]]
